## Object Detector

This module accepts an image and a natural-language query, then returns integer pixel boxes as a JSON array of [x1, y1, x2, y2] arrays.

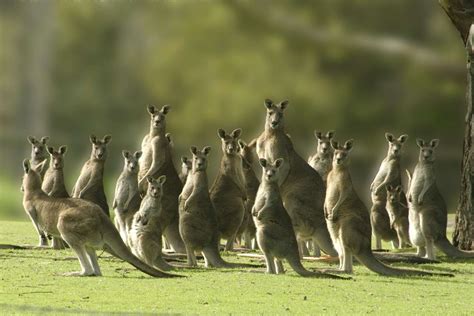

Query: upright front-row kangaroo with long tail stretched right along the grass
[[324, 140, 452, 276]]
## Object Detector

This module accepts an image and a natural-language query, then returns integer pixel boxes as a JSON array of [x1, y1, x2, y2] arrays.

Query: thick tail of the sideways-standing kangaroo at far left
[[103, 219, 181, 278]]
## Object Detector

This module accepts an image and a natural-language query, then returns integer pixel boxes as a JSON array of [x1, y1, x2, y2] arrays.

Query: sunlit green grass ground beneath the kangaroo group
[[0, 221, 474, 315]]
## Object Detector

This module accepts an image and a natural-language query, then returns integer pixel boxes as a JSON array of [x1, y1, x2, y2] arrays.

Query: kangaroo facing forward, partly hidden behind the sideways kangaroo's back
[[41, 146, 70, 249]]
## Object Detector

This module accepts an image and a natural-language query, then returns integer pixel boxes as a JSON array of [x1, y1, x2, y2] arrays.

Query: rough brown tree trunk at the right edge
[[439, 0, 474, 250]]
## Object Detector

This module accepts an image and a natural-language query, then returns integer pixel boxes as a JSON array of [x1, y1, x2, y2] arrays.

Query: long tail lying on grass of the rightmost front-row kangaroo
[[355, 249, 454, 277]]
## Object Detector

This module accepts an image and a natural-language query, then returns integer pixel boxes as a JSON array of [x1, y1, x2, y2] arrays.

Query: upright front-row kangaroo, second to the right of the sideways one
[[179, 146, 260, 268]]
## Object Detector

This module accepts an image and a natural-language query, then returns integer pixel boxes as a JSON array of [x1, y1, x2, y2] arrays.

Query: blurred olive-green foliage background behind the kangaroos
[[0, 0, 466, 219]]
